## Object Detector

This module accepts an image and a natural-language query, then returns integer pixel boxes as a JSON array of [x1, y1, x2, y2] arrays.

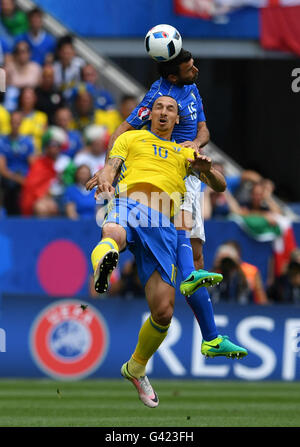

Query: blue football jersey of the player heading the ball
[[126, 78, 206, 143]]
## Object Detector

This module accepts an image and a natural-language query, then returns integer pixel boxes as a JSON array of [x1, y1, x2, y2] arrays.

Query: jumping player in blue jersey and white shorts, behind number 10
[[87, 49, 246, 357]]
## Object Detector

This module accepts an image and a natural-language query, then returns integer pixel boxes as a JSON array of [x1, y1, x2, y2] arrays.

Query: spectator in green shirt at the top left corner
[[1, 0, 28, 36]]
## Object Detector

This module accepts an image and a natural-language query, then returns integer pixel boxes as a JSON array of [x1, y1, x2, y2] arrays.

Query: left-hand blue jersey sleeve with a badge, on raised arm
[[126, 79, 162, 129]]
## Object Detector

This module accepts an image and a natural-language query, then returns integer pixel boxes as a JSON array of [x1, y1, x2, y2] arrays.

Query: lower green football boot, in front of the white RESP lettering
[[201, 335, 248, 359]]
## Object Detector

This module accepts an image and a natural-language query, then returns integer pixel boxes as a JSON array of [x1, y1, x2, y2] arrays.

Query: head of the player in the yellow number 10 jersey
[[150, 95, 179, 139]]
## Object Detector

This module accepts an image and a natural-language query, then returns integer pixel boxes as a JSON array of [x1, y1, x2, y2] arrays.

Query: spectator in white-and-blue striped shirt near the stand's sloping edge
[[54, 36, 85, 98]]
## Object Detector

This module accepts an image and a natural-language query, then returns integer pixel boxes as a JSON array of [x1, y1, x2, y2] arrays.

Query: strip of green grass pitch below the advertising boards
[[0, 379, 300, 427]]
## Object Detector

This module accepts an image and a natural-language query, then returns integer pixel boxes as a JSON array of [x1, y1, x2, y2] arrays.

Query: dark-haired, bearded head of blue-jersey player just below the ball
[[158, 48, 198, 86]]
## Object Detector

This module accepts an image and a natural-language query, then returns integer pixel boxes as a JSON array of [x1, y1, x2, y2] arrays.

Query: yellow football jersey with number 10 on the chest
[[109, 130, 194, 213]]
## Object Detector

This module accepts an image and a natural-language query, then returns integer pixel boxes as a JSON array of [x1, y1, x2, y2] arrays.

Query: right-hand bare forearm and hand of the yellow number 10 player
[[188, 151, 226, 192]]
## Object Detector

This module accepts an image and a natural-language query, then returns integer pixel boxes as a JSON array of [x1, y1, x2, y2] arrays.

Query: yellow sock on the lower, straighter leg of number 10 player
[[128, 315, 170, 377]]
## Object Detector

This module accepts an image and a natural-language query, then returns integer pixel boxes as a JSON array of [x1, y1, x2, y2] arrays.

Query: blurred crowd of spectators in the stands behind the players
[[0, 0, 300, 304]]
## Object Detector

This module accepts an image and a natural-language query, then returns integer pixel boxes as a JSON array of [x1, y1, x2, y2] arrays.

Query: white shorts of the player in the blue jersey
[[180, 175, 205, 242]]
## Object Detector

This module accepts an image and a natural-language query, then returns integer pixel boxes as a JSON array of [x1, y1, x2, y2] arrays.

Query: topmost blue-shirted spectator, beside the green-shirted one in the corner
[[16, 8, 56, 65]]
